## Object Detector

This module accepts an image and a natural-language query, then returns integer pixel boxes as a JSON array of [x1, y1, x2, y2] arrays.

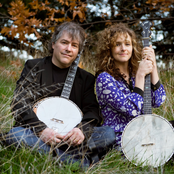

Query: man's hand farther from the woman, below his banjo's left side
[[39, 128, 64, 145]]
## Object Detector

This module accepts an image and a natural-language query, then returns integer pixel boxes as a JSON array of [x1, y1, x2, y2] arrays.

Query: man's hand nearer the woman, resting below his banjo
[[63, 128, 85, 146]]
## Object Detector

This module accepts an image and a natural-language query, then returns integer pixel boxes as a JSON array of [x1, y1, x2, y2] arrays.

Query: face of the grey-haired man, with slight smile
[[52, 32, 79, 68]]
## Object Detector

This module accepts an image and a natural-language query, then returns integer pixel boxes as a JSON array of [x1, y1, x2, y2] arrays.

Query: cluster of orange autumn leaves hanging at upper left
[[0, 0, 86, 45]]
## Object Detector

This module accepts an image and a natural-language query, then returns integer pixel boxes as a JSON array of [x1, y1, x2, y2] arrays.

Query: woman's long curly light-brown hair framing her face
[[93, 23, 142, 79]]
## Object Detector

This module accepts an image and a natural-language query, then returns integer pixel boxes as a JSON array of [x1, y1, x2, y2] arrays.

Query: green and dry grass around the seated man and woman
[[0, 52, 174, 174]]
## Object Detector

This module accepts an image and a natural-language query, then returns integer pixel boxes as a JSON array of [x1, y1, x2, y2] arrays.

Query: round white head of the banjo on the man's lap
[[33, 96, 82, 135]]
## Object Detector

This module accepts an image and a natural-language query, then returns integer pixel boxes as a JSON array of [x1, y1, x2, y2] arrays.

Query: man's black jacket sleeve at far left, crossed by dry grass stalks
[[11, 61, 46, 133]]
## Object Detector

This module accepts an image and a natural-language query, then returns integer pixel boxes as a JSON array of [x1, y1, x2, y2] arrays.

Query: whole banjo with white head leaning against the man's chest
[[33, 50, 83, 135]]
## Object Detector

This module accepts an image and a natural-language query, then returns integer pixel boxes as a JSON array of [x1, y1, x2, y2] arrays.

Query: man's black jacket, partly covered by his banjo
[[11, 57, 102, 137]]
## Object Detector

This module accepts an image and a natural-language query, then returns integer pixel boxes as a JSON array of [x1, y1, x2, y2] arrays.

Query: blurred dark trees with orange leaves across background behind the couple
[[0, 0, 174, 60]]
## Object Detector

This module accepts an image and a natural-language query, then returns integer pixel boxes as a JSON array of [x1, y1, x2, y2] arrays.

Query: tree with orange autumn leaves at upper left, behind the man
[[1, 0, 85, 54]]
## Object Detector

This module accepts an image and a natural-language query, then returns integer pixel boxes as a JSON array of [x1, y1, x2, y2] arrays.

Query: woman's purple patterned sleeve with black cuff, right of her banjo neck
[[151, 81, 166, 108]]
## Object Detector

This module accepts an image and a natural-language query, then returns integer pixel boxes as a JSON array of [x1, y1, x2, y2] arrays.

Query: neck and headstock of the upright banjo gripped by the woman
[[141, 21, 152, 114]]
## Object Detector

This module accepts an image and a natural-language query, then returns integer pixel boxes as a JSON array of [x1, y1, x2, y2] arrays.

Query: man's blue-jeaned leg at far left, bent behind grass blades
[[6, 127, 89, 167]]
